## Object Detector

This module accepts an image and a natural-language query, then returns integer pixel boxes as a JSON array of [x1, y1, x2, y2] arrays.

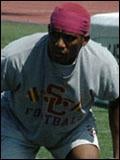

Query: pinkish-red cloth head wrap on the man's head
[[50, 2, 90, 36]]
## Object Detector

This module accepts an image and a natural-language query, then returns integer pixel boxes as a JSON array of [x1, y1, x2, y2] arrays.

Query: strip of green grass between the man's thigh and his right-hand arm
[[93, 107, 112, 159]]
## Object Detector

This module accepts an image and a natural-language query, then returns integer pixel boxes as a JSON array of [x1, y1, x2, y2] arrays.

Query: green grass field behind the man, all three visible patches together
[[1, 22, 112, 159]]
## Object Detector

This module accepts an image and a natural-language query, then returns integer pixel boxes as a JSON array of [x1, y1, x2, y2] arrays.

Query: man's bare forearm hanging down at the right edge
[[109, 98, 119, 159]]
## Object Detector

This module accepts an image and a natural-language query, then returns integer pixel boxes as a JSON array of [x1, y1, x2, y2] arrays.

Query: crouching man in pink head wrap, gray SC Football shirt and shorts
[[1, 3, 119, 159]]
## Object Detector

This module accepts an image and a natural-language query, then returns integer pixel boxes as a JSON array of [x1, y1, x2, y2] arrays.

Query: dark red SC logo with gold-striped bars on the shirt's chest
[[28, 84, 84, 116]]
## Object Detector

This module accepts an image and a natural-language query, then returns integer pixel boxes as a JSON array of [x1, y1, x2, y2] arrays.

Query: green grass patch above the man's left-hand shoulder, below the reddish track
[[1, 22, 47, 48]]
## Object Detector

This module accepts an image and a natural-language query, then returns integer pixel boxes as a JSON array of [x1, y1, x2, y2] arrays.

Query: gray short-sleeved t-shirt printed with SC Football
[[1, 33, 119, 146]]
